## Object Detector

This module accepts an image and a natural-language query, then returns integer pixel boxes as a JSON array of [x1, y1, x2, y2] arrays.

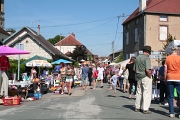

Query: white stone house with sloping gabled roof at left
[[3, 25, 69, 60]]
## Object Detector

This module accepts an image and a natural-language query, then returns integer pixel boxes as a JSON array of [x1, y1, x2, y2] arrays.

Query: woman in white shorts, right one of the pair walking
[[66, 64, 75, 95]]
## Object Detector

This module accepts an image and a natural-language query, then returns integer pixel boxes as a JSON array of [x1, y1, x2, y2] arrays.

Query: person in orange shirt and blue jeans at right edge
[[164, 46, 180, 118]]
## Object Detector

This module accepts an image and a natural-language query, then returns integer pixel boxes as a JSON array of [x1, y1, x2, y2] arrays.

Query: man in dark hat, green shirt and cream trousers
[[134, 46, 152, 114]]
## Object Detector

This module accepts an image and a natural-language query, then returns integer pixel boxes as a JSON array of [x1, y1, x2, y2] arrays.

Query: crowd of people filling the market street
[[27, 46, 180, 118]]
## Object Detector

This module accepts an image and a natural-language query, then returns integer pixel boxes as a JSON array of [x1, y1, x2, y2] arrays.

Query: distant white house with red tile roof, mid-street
[[55, 33, 93, 60]]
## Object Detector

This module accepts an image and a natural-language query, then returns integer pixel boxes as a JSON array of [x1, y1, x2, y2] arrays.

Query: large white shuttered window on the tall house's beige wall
[[159, 26, 168, 40]]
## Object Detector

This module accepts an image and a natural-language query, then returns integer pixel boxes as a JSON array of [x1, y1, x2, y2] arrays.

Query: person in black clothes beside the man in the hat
[[122, 56, 137, 99]]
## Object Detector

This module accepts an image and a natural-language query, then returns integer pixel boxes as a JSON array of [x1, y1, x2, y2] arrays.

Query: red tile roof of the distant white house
[[55, 33, 83, 46]]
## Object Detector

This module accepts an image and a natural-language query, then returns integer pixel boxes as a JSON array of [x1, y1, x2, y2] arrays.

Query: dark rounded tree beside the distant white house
[[71, 45, 87, 62]]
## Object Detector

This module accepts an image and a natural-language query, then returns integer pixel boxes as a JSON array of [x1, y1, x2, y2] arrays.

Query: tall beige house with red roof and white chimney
[[122, 0, 180, 66]]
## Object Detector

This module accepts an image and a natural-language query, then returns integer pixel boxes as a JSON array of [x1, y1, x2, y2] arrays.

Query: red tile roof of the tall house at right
[[123, 0, 180, 24]]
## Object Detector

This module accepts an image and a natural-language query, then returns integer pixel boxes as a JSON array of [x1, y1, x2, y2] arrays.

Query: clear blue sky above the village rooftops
[[4, 0, 139, 56]]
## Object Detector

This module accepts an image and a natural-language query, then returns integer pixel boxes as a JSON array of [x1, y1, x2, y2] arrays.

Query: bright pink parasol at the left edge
[[0, 45, 30, 55]]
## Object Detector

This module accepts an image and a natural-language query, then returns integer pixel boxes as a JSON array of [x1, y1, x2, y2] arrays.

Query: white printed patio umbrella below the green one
[[26, 60, 52, 67]]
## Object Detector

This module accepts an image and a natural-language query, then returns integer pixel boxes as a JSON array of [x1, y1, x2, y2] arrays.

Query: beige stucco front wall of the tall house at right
[[146, 15, 180, 51]]
